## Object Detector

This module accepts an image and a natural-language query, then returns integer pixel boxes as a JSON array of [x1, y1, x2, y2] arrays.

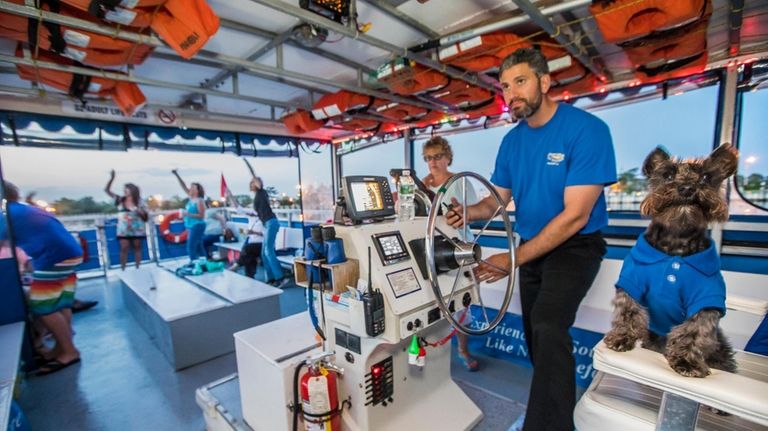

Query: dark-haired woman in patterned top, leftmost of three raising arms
[[104, 169, 149, 270]]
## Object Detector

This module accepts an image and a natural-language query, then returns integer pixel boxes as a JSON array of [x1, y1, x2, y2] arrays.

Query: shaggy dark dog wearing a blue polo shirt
[[605, 144, 738, 377]]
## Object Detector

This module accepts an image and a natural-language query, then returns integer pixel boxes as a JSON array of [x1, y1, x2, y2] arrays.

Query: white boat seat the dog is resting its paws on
[[574, 341, 768, 431]]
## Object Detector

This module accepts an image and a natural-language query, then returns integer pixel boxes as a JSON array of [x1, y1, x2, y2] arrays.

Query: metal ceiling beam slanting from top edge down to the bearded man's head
[[244, 0, 499, 93]]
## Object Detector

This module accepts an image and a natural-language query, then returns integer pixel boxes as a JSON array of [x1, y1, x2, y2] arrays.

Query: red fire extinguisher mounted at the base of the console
[[301, 366, 341, 431]]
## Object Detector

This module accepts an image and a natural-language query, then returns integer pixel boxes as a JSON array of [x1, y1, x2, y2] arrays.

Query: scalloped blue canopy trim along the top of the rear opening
[[0, 111, 326, 157]]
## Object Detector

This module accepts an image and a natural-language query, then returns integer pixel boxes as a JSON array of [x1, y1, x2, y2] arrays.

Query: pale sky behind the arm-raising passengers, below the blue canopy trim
[[0, 145, 299, 218]]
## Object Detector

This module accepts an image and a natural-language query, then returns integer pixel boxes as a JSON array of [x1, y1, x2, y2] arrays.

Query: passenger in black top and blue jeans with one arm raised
[[250, 177, 285, 286]]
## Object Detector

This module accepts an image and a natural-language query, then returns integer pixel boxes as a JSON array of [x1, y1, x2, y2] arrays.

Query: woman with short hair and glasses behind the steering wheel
[[421, 136, 479, 371]]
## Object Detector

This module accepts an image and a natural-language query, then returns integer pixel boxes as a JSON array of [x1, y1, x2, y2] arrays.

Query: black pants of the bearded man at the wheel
[[520, 232, 606, 431]]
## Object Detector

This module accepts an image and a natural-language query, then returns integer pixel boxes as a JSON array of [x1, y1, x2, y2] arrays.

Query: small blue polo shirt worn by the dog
[[616, 234, 725, 335]]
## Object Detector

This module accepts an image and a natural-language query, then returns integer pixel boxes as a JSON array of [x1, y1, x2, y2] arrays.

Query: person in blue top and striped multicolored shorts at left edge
[[0, 181, 83, 375]]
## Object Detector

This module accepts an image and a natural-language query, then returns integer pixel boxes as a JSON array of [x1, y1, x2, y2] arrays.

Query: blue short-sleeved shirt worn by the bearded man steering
[[491, 103, 616, 240]]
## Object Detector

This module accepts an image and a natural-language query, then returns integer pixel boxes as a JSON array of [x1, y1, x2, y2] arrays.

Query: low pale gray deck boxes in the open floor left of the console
[[119, 267, 282, 370]]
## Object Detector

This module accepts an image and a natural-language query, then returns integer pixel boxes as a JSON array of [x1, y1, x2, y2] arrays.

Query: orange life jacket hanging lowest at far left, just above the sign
[[16, 46, 147, 116]]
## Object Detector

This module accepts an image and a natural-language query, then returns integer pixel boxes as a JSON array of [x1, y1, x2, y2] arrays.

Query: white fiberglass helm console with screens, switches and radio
[[235, 174, 513, 431]]
